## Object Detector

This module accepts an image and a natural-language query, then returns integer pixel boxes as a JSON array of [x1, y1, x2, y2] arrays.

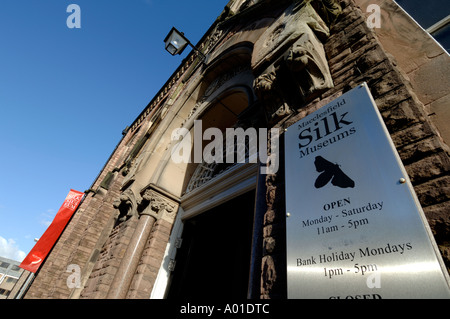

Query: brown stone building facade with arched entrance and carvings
[[25, 0, 450, 299]]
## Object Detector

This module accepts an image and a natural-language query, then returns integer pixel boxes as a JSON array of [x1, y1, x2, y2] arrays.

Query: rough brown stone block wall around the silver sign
[[261, 0, 450, 298]]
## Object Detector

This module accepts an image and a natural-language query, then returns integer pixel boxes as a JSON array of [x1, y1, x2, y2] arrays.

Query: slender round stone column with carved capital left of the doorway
[[106, 185, 176, 299]]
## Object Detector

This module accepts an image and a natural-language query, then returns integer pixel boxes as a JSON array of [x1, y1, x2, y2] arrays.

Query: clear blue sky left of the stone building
[[0, 0, 228, 261]]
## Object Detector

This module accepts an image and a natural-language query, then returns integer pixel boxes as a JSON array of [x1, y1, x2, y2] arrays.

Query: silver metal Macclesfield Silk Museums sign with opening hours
[[285, 84, 450, 299]]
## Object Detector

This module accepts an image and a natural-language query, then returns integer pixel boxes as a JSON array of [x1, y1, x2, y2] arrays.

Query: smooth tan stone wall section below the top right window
[[355, 0, 450, 147]]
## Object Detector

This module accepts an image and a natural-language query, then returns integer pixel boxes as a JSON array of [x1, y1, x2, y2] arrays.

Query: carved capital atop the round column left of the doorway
[[139, 188, 178, 220]]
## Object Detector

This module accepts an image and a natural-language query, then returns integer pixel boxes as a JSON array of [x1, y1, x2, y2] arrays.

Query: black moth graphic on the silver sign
[[314, 156, 355, 188]]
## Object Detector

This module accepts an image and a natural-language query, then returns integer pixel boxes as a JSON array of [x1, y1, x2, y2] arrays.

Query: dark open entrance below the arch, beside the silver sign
[[167, 191, 255, 300]]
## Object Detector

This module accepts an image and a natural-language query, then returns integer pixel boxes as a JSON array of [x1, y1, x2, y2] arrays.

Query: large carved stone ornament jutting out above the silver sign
[[252, 0, 340, 120]]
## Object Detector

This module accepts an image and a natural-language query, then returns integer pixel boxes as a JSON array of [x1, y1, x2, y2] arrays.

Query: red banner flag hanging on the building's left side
[[19, 189, 84, 273]]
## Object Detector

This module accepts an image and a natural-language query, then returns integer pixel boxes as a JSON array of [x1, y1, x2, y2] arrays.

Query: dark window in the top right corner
[[396, 0, 450, 52]]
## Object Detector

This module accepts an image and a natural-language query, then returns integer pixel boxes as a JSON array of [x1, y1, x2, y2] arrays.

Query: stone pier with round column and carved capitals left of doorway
[[80, 186, 177, 299]]
